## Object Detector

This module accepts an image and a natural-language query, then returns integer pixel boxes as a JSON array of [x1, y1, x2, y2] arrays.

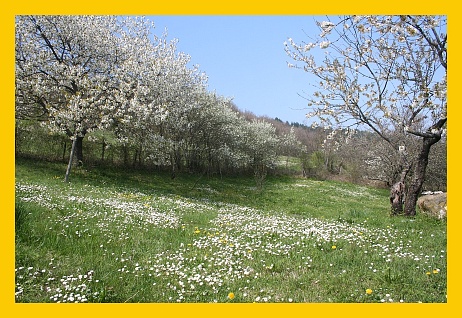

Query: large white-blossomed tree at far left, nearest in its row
[[16, 16, 140, 180]]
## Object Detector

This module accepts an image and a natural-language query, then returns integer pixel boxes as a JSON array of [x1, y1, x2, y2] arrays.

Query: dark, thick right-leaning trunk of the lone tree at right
[[404, 135, 441, 216]]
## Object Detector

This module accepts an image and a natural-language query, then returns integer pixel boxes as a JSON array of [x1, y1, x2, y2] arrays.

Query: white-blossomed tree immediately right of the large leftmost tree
[[113, 28, 206, 174]]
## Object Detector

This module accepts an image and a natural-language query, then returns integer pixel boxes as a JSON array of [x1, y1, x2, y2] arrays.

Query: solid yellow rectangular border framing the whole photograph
[[0, 0, 462, 318]]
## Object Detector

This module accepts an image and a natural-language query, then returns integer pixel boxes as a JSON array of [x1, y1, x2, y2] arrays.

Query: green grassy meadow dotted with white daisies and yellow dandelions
[[15, 159, 447, 303]]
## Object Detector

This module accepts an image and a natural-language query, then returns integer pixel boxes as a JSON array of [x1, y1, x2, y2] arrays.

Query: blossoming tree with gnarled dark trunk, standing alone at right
[[285, 16, 447, 215]]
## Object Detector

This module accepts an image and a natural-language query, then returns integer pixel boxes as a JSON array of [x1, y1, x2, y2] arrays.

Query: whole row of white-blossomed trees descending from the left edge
[[16, 16, 296, 181]]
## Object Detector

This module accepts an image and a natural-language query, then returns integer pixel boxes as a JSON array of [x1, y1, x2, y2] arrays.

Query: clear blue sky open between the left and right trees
[[150, 16, 318, 123]]
